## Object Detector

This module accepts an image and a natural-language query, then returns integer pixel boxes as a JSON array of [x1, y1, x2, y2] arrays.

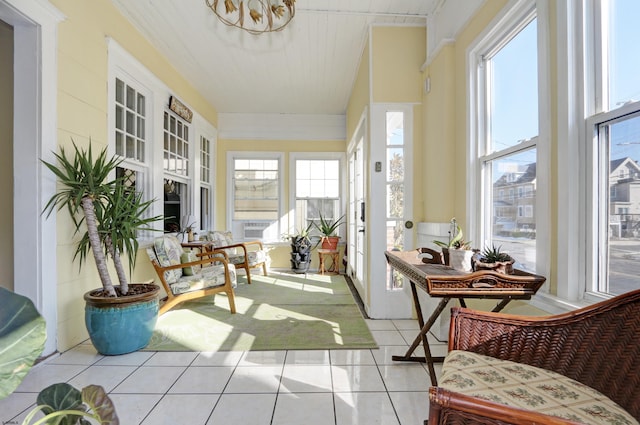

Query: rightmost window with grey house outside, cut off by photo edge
[[585, 0, 640, 295]]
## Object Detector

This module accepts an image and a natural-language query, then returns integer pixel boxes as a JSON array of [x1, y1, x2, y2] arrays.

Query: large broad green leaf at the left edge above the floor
[[0, 288, 47, 400]]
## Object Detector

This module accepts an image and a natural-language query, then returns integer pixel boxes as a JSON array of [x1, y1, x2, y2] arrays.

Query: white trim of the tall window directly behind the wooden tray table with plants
[[464, 0, 551, 293]]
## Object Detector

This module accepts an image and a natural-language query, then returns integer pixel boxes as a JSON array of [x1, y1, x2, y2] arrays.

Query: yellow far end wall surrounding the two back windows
[[215, 140, 346, 268]]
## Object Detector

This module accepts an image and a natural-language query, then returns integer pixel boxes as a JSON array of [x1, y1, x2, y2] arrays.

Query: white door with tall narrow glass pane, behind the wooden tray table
[[367, 104, 414, 319]]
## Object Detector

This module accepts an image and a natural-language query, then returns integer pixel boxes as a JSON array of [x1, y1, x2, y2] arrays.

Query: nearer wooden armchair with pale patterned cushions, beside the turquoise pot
[[147, 236, 236, 314]]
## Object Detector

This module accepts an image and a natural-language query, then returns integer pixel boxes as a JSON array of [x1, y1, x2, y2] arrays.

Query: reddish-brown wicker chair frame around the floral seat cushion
[[428, 290, 640, 425]]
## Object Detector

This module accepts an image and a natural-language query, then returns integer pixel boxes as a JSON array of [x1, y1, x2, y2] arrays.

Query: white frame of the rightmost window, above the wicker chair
[[576, 0, 640, 303]]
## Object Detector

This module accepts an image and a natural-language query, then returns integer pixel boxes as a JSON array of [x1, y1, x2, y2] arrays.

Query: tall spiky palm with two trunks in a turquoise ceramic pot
[[43, 143, 162, 355]]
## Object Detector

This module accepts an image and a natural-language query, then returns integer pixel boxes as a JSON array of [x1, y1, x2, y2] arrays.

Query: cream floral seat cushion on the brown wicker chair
[[439, 350, 638, 425]]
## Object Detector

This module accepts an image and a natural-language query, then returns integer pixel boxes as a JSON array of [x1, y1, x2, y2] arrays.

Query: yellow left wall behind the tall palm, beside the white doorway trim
[[52, 0, 217, 350]]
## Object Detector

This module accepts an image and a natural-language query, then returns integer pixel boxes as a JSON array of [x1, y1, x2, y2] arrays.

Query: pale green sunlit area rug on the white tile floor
[[145, 272, 377, 351]]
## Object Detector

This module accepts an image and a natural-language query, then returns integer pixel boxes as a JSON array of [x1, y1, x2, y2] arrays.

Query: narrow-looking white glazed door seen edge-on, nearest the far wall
[[347, 120, 368, 305]]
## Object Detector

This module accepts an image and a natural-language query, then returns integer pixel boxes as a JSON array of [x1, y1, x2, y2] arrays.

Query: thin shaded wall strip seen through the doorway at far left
[[0, 21, 13, 290]]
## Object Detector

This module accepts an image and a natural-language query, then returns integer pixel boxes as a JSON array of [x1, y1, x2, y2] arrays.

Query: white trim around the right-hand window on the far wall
[[288, 152, 347, 237]]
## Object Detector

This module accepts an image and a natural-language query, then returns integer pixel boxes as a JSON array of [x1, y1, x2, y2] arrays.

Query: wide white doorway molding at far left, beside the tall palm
[[0, 0, 65, 356]]
